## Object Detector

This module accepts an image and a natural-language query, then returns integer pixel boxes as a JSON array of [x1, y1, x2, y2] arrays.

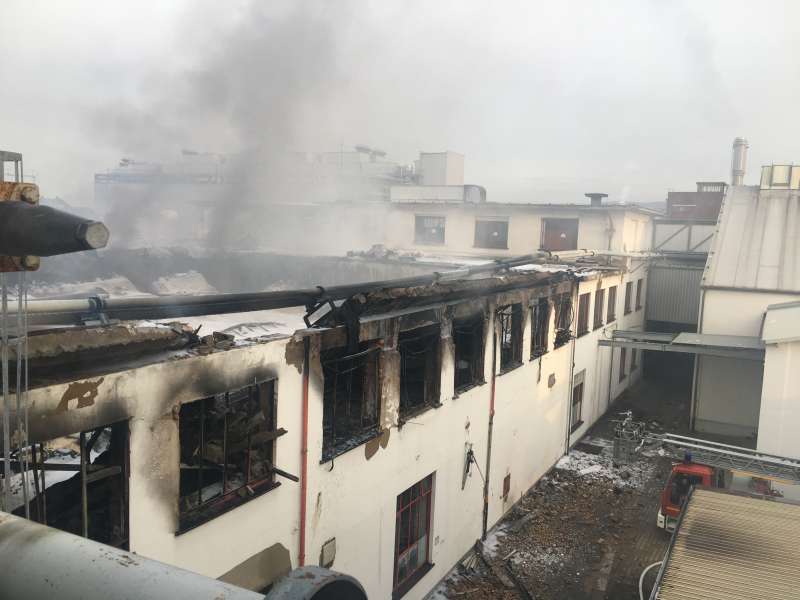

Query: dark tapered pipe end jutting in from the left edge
[[0, 202, 109, 256]]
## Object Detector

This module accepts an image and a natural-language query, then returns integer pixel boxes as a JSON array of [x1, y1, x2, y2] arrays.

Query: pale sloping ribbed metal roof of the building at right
[[703, 186, 800, 293]]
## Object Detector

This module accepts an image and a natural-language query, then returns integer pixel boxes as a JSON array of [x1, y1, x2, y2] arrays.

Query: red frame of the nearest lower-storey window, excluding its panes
[[392, 472, 436, 599]]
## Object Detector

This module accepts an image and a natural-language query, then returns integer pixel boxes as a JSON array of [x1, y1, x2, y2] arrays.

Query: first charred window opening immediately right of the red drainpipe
[[321, 344, 380, 462]]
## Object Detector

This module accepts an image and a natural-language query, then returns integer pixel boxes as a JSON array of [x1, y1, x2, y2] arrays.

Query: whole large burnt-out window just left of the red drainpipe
[[178, 380, 284, 533]]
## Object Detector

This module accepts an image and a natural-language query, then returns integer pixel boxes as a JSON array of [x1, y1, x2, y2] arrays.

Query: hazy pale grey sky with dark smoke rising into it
[[0, 0, 800, 205]]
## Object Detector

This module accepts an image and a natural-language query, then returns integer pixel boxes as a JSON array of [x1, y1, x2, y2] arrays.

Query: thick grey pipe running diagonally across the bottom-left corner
[[0, 513, 264, 600]]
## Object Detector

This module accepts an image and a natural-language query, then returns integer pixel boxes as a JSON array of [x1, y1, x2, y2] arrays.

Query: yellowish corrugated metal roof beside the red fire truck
[[651, 488, 800, 600]]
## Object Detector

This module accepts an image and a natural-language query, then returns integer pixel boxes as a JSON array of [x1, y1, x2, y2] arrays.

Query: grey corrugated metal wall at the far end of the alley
[[645, 264, 703, 325]]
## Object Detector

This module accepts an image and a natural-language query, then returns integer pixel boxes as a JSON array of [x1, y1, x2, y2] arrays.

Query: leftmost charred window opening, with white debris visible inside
[[12, 421, 128, 549]]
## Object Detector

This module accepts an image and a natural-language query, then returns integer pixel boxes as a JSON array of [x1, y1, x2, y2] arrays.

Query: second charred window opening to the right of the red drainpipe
[[397, 323, 441, 419]]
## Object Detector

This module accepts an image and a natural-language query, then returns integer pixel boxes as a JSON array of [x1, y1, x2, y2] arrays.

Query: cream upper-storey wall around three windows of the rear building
[[386, 203, 652, 256]]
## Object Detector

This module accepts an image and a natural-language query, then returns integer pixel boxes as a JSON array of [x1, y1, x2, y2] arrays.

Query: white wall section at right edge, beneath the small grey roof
[[758, 341, 800, 458]]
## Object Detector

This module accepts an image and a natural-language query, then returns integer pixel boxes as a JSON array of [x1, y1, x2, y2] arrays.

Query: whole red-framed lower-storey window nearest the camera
[[392, 474, 433, 598]]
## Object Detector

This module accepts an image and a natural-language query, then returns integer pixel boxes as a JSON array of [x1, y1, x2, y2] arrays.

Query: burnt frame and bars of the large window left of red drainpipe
[[175, 378, 286, 535]]
